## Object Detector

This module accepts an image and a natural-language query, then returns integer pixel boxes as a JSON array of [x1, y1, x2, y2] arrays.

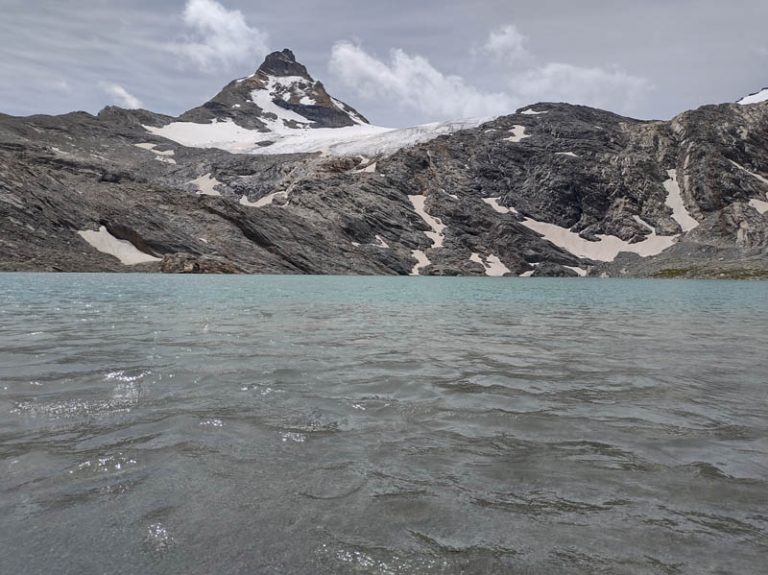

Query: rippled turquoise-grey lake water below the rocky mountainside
[[0, 274, 768, 575]]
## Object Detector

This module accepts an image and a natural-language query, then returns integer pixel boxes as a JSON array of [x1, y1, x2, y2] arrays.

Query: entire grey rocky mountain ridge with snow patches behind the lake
[[0, 50, 768, 277]]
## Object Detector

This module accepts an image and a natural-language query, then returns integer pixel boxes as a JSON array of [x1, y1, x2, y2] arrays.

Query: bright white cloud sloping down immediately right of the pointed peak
[[330, 42, 513, 118]]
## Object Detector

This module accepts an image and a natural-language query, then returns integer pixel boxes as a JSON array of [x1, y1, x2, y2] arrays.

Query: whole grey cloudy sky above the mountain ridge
[[0, 0, 768, 126]]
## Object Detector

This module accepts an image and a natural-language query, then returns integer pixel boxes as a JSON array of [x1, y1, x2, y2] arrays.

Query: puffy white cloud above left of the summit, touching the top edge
[[168, 0, 268, 70]]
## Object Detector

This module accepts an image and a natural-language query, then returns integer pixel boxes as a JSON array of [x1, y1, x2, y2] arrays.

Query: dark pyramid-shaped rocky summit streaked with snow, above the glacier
[[179, 49, 368, 133]]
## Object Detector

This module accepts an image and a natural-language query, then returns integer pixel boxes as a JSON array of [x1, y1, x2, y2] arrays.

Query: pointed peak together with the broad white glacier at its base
[[145, 50, 485, 156]]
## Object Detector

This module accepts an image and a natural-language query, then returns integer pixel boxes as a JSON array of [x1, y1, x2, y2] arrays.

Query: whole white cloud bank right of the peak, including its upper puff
[[330, 26, 651, 119]]
